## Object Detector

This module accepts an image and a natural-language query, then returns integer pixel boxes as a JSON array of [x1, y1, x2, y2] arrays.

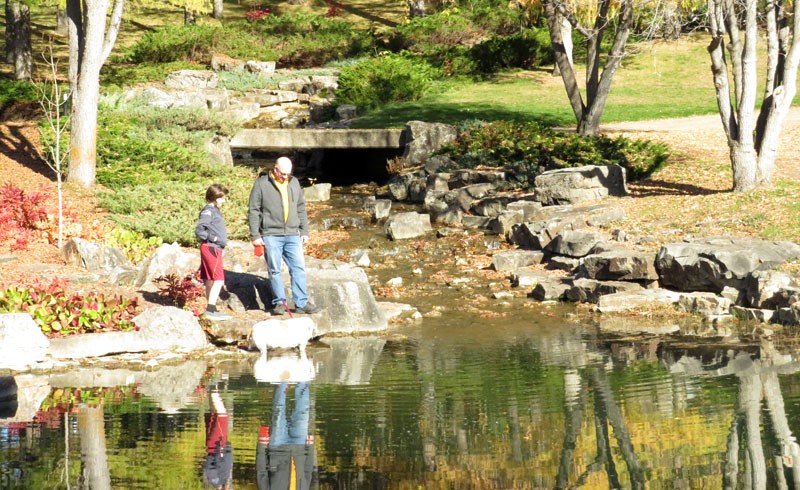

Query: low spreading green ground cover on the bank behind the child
[[97, 99, 255, 246]]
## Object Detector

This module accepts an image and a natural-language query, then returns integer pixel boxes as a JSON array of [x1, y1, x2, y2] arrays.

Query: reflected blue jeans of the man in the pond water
[[270, 382, 310, 447]]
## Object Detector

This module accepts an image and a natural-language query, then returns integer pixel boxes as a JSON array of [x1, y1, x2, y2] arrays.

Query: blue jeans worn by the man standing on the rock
[[262, 235, 308, 308]]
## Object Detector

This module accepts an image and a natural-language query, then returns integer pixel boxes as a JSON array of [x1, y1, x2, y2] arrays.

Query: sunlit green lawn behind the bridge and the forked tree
[[358, 35, 717, 127]]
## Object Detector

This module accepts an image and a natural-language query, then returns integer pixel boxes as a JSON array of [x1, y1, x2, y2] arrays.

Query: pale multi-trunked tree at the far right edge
[[708, 0, 800, 192]]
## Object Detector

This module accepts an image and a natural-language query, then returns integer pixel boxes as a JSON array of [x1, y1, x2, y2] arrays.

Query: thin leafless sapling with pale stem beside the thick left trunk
[[38, 46, 69, 248]]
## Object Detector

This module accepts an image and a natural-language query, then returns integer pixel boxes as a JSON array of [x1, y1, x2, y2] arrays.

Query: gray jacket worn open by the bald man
[[247, 173, 308, 240]]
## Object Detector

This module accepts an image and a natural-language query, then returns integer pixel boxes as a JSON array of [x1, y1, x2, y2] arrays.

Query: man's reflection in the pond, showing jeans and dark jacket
[[256, 382, 316, 490]]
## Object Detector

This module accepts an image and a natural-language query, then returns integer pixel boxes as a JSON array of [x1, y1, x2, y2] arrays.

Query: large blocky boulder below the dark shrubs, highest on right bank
[[534, 165, 626, 205]]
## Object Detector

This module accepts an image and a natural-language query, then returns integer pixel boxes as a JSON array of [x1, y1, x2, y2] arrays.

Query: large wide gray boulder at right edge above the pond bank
[[656, 237, 800, 293]]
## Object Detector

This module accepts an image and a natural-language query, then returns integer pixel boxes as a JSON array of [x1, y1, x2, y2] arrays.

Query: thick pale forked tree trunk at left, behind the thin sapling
[[67, 0, 125, 187]]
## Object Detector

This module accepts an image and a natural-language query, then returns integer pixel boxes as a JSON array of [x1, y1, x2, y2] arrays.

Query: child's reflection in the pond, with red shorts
[[203, 391, 233, 490]]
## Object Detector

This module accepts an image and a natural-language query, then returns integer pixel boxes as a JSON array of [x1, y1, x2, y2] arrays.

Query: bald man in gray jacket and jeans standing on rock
[[248, 157, 321, 315]]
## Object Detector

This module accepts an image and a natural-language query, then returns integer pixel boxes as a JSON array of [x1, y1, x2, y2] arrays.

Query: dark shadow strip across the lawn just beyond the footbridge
[[352, 102, 574, 128]]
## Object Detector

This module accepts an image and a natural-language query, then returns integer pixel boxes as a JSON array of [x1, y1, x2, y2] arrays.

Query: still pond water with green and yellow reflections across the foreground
[[0, 312, 800, 490]]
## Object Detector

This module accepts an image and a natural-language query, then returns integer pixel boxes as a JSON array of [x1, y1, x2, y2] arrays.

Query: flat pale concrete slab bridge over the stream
[[230, 129, 405, 151]]
